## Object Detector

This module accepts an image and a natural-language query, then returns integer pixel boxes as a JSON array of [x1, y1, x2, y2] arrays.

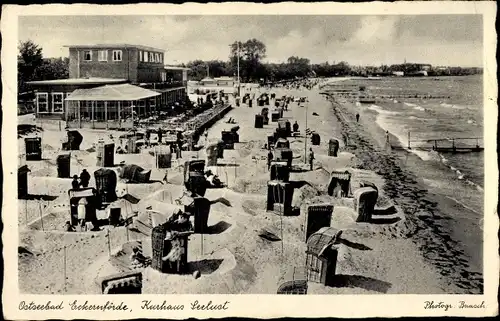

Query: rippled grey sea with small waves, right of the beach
[[357, 75, 488, 272]]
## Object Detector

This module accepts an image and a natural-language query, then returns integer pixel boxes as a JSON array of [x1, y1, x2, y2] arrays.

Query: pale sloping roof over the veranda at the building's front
[[66, 84, 160, 101]]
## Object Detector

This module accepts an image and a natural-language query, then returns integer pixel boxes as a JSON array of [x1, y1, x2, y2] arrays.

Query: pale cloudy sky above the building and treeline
[[18, 15, 483, 67]]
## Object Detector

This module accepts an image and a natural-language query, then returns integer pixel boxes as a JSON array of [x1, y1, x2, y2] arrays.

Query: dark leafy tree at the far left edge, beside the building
[[17, 40, 43, 92]]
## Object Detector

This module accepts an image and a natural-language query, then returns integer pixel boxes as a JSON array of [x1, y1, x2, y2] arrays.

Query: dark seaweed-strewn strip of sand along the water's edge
[[328, 96, 483, 293]]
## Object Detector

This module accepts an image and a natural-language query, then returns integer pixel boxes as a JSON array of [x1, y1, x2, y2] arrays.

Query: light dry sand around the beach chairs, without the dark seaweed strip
[[19, 82, 450, 294]]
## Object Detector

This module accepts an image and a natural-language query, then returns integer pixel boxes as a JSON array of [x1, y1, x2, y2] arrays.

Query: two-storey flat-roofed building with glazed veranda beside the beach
[[28, 44, 188, 128]]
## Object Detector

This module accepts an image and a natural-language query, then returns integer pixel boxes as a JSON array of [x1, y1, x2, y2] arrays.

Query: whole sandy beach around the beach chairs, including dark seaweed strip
[[19, 79, 482, 294]]
